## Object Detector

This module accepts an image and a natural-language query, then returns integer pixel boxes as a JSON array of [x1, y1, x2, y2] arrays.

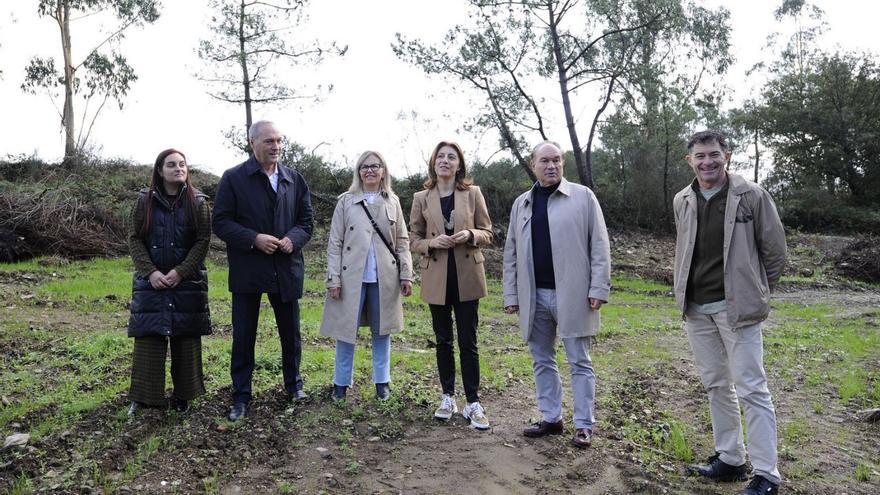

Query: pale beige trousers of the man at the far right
[[684, 310, 780, 484]]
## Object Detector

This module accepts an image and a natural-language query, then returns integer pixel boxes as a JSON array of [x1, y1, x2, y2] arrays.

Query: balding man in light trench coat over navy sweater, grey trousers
[[504, 141, 611, 448]]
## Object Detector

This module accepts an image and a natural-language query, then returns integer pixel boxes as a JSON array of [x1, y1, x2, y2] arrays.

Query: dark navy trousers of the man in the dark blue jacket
[[230, 292, 303, 403]]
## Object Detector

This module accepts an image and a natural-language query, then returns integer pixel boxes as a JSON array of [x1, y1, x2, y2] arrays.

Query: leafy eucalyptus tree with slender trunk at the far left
[[21, 0, 160, 164]]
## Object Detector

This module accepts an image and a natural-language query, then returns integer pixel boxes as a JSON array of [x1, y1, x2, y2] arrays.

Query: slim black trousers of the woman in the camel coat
[[429, 299, 480, 402]]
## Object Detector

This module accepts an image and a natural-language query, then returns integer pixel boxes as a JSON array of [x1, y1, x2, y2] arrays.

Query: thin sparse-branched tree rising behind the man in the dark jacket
[[197, 0, 348, 149]]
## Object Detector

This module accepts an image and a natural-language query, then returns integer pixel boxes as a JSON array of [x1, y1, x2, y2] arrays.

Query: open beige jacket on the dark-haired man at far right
[[672, 173, 786, 328]]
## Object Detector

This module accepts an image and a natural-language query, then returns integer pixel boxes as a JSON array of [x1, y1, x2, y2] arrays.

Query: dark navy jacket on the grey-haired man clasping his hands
[[213, 156, 314, 301]]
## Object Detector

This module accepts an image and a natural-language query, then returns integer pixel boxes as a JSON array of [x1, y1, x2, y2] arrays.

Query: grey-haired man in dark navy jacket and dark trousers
[[213, 121, 314, 421]]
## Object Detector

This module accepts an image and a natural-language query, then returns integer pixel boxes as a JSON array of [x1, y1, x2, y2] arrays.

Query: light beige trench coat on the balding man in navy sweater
[[504, 179, 611, 341]]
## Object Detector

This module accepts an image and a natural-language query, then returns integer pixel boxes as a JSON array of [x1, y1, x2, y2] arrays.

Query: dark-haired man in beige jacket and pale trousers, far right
[[673, 131, 785, 495]]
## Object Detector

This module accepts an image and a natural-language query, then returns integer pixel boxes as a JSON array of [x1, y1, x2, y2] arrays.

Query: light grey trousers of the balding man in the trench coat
[[529, 289, 596, 430]]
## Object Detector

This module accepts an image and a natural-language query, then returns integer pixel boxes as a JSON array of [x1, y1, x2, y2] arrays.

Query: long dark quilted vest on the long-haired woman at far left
[[128, 192, 211, 337]]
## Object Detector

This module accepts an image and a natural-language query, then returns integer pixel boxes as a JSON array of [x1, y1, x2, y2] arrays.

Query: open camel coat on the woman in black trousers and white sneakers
[[409, 186, 493, 304]]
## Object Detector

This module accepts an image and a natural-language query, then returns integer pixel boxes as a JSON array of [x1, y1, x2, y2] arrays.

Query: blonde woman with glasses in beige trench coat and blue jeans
[[321, 151, 412, 400]]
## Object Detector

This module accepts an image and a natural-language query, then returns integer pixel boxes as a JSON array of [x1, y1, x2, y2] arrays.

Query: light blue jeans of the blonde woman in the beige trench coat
[[333, 283, 391, 387]]
